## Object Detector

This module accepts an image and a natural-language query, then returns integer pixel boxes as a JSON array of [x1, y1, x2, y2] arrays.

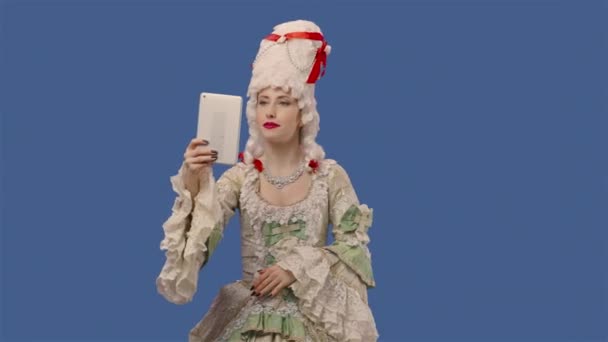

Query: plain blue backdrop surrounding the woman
[[0, 0, 608, 342]]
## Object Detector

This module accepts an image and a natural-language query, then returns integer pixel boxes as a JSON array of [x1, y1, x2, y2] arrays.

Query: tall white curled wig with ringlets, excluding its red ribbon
[[243, 20, 331, 164]]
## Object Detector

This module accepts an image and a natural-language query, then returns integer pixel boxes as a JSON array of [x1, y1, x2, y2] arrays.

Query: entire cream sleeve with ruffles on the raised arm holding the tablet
[[156, 164, 243, 304]]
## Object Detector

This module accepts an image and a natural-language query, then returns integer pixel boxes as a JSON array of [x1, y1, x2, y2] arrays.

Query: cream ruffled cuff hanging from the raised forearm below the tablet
[[156, 164, 221, 304]]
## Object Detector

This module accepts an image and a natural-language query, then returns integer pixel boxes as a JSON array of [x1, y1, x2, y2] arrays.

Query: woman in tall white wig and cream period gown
[[157, 20, 378, 342]]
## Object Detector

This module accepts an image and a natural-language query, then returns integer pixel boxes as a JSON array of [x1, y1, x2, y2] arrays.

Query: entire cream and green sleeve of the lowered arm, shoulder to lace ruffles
[[277, 163, 378, 341]]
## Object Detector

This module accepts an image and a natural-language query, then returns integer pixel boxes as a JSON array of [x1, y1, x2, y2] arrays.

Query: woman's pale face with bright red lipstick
[[255, 87, 302, 143]]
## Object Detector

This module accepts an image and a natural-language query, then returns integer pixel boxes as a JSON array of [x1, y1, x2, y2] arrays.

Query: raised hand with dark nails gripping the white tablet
[[184, 138, 217, 199]]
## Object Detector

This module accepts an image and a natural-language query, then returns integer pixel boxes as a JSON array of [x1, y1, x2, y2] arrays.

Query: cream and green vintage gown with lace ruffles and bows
[[156, 159, 378, 342]]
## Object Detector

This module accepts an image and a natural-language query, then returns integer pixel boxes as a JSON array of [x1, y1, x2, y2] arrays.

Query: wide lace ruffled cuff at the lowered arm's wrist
[[277, 246, 378, 341]]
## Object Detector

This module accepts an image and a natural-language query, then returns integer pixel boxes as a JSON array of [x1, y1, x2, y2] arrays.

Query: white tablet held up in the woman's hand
[[196, 93, 243, 165]]
